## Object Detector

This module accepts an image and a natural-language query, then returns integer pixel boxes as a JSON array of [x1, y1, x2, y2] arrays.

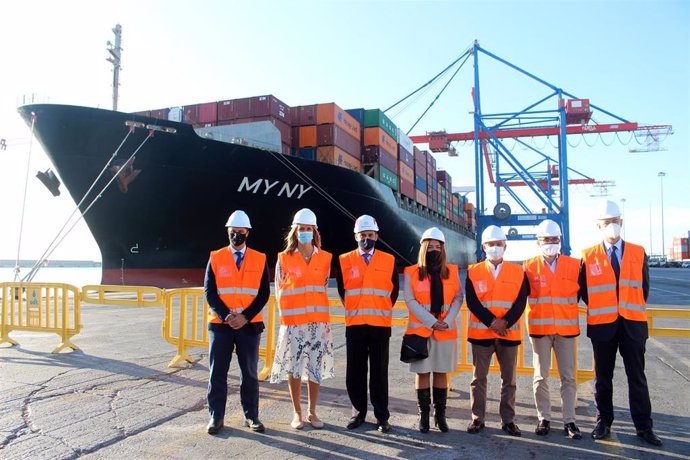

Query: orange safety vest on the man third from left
[[339, 249, 395, 327]]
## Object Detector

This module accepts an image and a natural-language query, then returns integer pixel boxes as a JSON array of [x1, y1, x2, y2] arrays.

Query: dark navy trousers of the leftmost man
[[207, 325, 261, 420]]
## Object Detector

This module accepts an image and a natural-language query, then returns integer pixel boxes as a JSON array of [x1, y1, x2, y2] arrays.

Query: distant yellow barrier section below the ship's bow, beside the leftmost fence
[[81, 284, 165, 307]]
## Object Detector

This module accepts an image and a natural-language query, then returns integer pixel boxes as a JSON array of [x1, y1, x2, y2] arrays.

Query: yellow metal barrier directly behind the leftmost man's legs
[[161, 288, 276, 380]]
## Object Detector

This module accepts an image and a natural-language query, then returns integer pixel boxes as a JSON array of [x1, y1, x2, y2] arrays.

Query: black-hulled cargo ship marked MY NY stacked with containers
[[19, 96, 475, 288]]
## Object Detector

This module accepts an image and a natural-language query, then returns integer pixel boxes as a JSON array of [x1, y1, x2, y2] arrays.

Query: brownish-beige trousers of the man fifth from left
[[470, 339, 519, 424]]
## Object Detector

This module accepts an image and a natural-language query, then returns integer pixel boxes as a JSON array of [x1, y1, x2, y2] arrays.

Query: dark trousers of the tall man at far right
[[592, 328, 652, 430]]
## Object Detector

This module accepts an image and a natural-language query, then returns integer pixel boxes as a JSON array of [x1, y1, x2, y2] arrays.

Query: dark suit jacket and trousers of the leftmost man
[[204, 256, 271, 420]]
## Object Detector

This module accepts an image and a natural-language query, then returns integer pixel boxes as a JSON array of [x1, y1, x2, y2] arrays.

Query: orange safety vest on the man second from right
[[524, 255, 580, 336]]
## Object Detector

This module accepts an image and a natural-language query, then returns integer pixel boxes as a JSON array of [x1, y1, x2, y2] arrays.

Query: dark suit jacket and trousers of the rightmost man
[[579, 241, 652, 430]]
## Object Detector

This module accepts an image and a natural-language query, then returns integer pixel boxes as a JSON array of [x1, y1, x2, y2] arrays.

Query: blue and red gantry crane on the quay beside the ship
[[398, 41, 673, 258]]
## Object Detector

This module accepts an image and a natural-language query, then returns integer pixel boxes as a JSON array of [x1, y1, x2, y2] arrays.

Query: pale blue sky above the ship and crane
[[0, 0, 690, 259]]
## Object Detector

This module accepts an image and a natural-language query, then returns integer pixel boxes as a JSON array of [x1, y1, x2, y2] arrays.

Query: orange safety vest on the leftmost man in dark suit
[[207, 246, 266, 324]]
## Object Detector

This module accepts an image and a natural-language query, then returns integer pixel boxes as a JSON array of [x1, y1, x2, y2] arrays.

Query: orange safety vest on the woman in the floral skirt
[[278, 250, 331, 326]]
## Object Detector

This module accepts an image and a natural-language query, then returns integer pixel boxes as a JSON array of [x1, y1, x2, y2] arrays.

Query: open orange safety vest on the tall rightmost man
[[582, 242, 647, 325]]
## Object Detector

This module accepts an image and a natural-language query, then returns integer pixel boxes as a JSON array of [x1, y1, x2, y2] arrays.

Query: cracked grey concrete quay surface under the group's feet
[[0, 304, 690, 460]]
